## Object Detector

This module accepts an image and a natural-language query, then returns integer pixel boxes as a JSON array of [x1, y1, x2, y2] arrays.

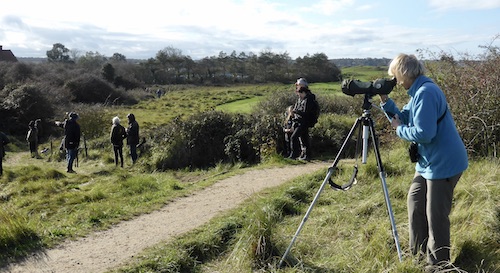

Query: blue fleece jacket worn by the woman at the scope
[[381, 75, 468, 179]]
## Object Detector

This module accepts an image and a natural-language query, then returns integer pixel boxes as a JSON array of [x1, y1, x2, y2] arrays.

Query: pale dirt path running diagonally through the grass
[[3, 162, 331, 273]]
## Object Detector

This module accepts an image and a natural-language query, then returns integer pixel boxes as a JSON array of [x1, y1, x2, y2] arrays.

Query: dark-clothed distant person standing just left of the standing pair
[[56, 112, 81, 173]]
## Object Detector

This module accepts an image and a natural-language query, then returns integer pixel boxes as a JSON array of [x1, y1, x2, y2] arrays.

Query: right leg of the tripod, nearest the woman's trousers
[[369, 119, 403, 262]]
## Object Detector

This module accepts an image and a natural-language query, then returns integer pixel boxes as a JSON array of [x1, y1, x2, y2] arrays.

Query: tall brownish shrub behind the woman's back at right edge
[[427, 44, 500, 156]]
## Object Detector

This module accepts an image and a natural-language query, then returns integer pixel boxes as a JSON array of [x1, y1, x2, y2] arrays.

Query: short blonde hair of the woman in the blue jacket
[[387, 53, 425, 84]]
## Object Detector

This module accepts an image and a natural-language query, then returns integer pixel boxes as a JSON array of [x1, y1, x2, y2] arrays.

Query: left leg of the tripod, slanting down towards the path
[[278, 118, 361, 267]]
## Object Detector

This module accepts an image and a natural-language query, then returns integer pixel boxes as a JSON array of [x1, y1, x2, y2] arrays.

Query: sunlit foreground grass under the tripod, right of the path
[[113, 153, 500, 273]]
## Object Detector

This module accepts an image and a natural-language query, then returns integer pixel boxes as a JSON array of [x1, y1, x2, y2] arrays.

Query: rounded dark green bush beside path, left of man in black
[[151, 111, 258, 170]]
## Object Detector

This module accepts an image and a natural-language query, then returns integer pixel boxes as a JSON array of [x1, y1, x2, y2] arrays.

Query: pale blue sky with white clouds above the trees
[[0, 0, 500, 60]]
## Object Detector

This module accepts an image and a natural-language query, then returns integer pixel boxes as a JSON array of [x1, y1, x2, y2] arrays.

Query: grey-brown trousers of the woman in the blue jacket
[[407, 173, 462, 265]]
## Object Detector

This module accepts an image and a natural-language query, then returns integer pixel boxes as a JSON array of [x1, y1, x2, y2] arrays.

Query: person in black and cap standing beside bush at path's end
[[288, 78, 319, 160]]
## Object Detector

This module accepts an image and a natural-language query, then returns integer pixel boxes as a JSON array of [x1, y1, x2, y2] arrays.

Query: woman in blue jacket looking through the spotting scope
[[380, 54, 468, 271]]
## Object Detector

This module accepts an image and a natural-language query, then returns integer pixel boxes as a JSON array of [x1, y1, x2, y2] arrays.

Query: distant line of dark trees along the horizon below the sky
[[47, 43, 341, 84]]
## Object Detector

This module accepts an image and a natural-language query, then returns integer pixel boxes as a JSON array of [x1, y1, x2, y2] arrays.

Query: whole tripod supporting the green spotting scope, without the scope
[[279, 94, 403, 267]]
